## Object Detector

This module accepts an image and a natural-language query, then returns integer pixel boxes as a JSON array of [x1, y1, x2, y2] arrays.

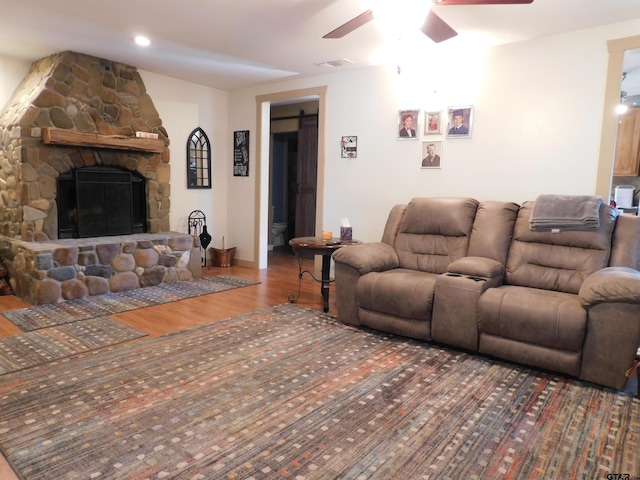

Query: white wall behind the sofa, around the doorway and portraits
[[229, 20, 640, 260]]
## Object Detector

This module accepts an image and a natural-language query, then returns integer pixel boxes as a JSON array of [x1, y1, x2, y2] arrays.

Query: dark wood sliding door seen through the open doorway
[[296, 116, 318, 237]]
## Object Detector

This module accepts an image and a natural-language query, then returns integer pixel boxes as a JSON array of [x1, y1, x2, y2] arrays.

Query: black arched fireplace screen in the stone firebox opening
[[57, 167, 147, 238]]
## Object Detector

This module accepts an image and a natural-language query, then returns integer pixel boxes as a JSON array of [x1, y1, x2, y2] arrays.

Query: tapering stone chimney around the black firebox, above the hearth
[[0, 52, 170, 241]]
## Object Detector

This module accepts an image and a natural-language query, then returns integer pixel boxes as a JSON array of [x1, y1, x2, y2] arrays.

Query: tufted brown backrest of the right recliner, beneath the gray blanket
[[505, 202, 616, 293]]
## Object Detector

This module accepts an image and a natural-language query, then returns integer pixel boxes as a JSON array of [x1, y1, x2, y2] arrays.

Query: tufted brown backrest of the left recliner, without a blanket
[[395, 198, 478, 273]]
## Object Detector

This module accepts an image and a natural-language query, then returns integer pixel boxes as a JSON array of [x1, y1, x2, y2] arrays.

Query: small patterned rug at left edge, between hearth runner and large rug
[[0, 317, 146, 375]]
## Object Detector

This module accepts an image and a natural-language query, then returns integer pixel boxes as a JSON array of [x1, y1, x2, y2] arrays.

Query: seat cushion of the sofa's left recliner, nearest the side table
[[356, 268, 437, 321]]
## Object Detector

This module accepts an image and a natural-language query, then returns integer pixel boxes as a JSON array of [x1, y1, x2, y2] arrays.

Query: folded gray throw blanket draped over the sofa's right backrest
[[529, 195, 603, 232]]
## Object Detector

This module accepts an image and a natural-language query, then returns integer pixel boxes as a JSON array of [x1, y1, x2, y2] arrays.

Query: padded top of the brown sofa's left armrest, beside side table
[[332, 242, 400, 275]]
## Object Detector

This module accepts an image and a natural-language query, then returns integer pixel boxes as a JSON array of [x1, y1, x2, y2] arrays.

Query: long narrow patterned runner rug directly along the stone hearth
[[2, 275, 260, 331]]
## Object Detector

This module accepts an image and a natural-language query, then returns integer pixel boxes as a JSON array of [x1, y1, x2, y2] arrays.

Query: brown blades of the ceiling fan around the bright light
[[322, 0, 533, 43]]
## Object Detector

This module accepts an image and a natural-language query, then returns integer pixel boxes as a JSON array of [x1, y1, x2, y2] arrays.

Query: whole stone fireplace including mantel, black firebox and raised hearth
[[0, 52, 201, 303]]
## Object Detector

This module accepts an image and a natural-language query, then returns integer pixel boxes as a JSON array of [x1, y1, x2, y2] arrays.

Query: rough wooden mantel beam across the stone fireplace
[[42, 127, 165, 153]]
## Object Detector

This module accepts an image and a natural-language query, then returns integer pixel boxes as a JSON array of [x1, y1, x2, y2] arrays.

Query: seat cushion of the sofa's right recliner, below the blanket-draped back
[[478, 285, 587, 352]]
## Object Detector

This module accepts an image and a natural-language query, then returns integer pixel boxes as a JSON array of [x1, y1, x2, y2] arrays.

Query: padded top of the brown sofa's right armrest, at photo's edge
[[578, 267, 640, 308]]
